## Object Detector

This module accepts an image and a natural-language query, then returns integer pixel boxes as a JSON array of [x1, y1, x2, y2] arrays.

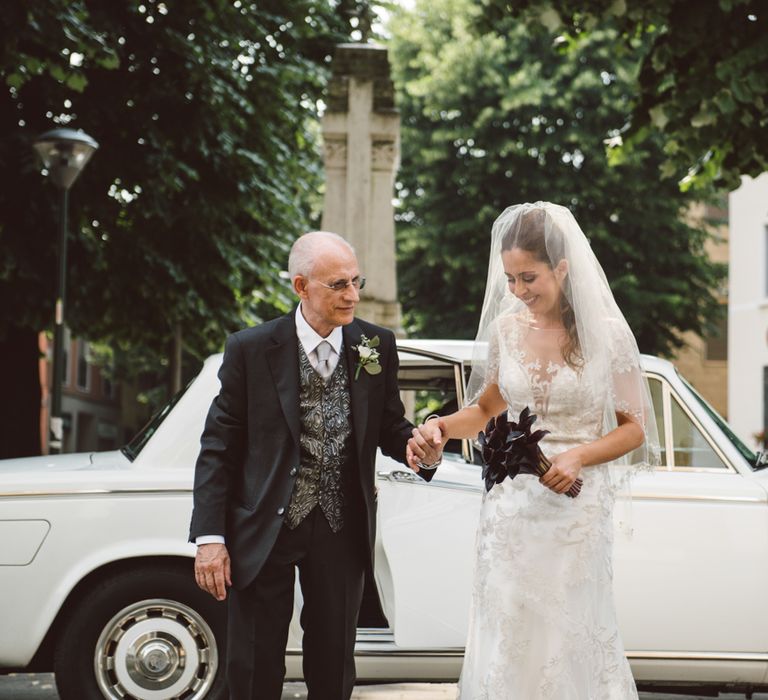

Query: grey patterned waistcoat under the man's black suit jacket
[[286, 343, 352, 532]]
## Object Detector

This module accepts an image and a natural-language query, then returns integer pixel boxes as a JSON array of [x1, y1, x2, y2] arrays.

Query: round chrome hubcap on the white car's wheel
[[94, 600, 218, 700]]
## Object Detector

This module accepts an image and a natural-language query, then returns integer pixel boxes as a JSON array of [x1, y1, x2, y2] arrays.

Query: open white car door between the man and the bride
[[376, 350, 481, 649]]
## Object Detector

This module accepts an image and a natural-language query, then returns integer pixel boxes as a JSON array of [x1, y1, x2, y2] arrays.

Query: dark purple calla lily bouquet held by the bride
[[477, 406, 583, 498]]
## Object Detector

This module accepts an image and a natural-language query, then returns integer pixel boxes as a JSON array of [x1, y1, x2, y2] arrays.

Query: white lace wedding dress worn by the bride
[[459, 318, 637, 700]]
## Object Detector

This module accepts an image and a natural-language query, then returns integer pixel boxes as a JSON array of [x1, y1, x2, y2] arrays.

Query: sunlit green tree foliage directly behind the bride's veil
[[390, 0, 724, 354]]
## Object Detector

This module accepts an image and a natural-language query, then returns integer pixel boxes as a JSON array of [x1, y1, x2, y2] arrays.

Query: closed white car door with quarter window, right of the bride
[[614, 375, 768, 680]]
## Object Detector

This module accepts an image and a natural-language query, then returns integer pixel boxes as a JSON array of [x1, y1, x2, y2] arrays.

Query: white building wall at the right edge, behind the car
[[728, 173, 768, 447]]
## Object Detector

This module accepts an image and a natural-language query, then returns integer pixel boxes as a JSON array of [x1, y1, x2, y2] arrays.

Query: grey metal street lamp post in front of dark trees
[[34, 129, 99, 453]]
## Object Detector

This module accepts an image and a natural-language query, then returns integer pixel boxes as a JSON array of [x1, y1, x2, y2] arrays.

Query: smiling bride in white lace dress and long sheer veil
[[414, 202, 658, 700]]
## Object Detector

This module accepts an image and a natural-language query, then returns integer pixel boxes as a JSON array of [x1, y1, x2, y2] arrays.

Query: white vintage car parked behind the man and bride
[[0, 341, 768, 700]]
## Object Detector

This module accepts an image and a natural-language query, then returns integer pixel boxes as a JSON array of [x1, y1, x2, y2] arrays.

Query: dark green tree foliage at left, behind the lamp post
[[0, 0, 359, 456]]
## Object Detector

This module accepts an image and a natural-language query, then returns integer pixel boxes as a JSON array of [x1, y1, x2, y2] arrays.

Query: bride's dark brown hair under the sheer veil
[[501, 209, 583, 369]]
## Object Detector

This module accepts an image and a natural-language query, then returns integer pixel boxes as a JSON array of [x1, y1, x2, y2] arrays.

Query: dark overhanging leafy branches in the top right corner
[[482, 0, 768, 189]]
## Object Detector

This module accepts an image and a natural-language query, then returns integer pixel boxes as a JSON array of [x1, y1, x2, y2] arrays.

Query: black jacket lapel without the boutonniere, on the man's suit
[[266, 311, 301, 445]]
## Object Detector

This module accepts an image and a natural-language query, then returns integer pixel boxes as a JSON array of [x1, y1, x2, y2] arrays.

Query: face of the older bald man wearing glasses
[[294, 243, 360, 337]]
